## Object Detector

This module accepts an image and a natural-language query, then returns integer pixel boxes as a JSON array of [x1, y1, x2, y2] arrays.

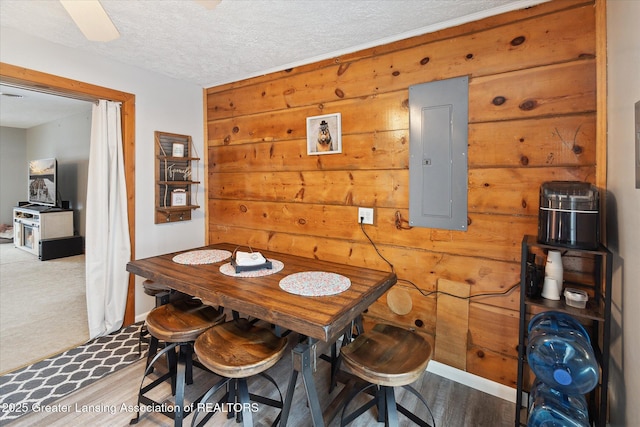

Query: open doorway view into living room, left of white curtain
[[0, 85, 92, 374]]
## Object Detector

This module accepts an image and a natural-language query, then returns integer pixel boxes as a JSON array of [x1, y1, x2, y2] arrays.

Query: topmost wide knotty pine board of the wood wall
[[207, 7, 595, 121]]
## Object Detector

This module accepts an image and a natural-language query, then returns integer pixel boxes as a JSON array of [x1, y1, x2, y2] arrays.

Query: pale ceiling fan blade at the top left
[[60, 0, 120, 42]]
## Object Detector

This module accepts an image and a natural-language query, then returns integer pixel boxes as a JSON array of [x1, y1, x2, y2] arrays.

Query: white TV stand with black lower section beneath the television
[[13, 205, 84, 261]]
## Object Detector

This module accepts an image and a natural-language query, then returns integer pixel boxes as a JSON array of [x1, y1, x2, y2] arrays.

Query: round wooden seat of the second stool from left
[[146, 300, 225, 342]]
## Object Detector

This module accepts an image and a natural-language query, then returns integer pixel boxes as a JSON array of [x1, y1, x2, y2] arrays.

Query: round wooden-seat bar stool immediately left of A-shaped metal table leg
[[191, 318, 287, 427]]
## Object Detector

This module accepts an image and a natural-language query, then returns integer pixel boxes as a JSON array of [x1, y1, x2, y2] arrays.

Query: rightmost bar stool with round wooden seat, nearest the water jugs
[[340, 324, 435, 426]]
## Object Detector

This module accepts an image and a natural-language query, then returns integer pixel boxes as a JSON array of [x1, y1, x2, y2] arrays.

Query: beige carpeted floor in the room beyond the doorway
[[0, 243, 89, 374]]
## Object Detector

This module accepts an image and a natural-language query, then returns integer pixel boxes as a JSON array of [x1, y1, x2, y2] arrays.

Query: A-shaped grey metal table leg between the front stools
[[280, 338, 324, 427]]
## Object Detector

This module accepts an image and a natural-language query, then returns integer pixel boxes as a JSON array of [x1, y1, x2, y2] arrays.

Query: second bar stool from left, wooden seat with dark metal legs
[[131, 299, 225, 426]]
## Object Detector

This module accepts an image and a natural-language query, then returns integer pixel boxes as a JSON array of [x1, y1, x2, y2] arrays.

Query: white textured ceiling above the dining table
[[0, 0, 545, 128]]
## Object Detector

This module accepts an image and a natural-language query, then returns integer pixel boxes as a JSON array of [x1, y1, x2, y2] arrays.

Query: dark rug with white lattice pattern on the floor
[[0, 323, 148, 425]]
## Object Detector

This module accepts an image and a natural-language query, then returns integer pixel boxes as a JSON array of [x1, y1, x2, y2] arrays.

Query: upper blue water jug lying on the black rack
[[527, 311, 600, 394]]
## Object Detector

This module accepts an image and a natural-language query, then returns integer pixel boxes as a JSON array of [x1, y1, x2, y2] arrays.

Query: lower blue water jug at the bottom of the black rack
[[527, 380, 589, 427]]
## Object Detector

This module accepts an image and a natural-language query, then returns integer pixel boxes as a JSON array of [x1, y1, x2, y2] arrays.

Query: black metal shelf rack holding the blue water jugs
[[515, 236, 612, 427]]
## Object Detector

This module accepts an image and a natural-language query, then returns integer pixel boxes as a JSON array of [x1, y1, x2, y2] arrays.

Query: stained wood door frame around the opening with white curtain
[[0, 62, 136, 326]]
